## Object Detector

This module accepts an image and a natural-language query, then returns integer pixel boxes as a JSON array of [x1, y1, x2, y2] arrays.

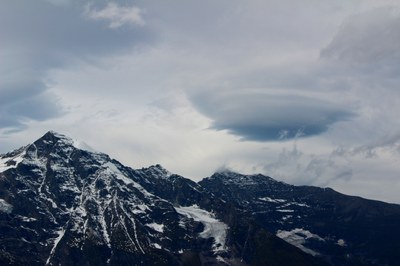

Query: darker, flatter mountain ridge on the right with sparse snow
[[199, 172, 400, 265]]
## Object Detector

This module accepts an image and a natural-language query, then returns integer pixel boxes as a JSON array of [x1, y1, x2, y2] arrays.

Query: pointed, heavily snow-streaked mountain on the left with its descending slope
[[0, 132, 326, 265]]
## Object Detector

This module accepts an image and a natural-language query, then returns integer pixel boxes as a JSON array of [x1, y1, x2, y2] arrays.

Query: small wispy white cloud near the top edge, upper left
[[85, 2, 145, 29]]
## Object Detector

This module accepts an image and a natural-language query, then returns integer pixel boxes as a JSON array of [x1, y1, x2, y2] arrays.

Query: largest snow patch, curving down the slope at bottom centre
[[175, 205, 228, 253]]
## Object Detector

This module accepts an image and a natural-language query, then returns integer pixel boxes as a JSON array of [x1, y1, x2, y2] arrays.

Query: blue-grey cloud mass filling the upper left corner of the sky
[[0, 1, 152, 130]]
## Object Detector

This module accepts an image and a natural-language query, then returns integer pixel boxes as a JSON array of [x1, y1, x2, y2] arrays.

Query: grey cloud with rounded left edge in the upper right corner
[[321, 7, 400, 66]]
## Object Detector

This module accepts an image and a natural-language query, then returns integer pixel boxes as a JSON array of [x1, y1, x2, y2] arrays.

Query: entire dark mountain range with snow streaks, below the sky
[[0, 131, 400, 265]]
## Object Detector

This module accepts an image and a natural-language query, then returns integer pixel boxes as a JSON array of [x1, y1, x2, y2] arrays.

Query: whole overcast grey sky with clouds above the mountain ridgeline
[[0, 0, 400, 203]]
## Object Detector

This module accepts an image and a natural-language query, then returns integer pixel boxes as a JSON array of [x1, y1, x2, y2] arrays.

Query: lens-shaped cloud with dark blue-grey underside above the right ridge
[[193, 91, 352, 141]]
